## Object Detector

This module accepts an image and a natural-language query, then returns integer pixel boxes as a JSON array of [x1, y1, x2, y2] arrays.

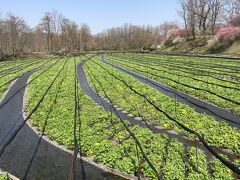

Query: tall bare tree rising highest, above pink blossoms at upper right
[[178, 0, 225, 37]]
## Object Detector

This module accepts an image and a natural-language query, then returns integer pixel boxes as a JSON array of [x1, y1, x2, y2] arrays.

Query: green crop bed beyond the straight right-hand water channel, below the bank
[[107, 54, 240, 114]]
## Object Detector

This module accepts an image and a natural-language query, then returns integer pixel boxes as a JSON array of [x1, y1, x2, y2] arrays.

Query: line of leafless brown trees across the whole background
[[0, 0, 240, 55]]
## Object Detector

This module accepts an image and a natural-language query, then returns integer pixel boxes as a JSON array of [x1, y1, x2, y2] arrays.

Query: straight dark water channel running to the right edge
[[102, 59, 240, 129]]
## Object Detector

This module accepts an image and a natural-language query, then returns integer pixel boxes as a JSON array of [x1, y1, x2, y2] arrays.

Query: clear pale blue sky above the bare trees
[[0, 0, 179, 34]]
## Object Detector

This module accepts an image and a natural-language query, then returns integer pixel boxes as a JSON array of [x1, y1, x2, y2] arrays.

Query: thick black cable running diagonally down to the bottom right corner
[[92, 58, 240, 174]]
